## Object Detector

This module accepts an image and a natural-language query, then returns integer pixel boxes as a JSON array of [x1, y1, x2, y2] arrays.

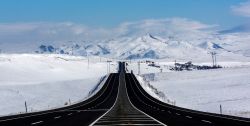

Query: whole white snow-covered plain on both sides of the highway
[[0, 54, 250, 117]]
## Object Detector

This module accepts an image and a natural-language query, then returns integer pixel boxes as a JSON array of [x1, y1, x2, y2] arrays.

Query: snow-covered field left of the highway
[[0, 54, 117, 116]]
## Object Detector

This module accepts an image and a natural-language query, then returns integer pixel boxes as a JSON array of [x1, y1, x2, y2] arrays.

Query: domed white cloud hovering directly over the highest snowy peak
[[116, 18, 217, 39]]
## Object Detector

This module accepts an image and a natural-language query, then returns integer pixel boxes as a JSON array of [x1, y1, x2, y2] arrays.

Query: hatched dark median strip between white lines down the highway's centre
[[93, 61, 164, 126]]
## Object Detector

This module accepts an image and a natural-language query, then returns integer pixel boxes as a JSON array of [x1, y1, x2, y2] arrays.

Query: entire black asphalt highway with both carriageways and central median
[[0, 62, 250, 126]]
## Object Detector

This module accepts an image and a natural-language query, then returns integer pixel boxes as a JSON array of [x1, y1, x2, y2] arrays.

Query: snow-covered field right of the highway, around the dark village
[[129, 62, 250, 118]]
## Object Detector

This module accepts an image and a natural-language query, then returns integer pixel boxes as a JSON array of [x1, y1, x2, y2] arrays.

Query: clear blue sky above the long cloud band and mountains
[[0, 0, 249, 28]]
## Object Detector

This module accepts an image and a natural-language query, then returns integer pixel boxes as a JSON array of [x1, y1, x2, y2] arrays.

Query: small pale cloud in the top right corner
[[231, 1, 250, 17]]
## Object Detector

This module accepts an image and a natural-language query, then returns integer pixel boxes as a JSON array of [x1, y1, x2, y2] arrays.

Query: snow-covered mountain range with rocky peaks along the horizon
[[30, 33, 250, 60]]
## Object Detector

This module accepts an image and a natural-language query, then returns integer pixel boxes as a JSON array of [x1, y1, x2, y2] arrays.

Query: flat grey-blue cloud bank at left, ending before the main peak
[[0, 22, 112, 44]]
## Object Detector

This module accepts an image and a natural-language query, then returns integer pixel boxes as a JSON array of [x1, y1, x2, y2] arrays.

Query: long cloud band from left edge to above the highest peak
[[0, 18, 215, 44]]
